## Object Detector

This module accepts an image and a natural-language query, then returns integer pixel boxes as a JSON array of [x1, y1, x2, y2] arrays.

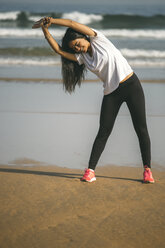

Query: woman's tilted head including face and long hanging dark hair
[[61, 28, 90, 93]]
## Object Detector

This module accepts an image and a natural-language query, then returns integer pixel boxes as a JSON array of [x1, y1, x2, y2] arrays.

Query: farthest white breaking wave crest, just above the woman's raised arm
[[62, 11, 103, 24]]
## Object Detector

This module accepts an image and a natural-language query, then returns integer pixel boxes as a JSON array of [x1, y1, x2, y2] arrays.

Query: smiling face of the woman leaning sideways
[[69, 38, 90, 53]]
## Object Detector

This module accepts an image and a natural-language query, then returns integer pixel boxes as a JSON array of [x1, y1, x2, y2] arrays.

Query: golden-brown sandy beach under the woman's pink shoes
[[0, 165, 165, 248]]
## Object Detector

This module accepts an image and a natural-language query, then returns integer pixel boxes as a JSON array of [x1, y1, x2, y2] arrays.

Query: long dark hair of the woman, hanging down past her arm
[[61, 28, 89, 93]]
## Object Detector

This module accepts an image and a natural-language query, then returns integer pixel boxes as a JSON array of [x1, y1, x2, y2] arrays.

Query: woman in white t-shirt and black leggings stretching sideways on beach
[[33, 17, 154, 183]]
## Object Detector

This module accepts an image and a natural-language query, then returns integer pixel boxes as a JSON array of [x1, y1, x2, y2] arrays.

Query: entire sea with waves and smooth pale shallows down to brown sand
[[0, 3, 165, 168]]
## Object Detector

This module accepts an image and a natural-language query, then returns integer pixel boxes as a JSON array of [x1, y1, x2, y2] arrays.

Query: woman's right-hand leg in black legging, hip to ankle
[[126, 75, 151, 168]]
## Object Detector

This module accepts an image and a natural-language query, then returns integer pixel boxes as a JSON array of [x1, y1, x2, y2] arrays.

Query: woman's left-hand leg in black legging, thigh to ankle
[[88, 88, 122, 170]]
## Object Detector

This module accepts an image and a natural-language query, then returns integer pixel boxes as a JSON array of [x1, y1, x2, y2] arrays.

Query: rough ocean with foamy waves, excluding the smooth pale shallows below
[[0, 4, 165, 76]]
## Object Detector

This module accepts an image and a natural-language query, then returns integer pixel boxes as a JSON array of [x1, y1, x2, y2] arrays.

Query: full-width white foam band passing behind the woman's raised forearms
[[0, 28, 165, 40]]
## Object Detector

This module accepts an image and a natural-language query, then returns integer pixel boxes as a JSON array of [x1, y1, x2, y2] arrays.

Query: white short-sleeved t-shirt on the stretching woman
[[75, 29, 133, 95]]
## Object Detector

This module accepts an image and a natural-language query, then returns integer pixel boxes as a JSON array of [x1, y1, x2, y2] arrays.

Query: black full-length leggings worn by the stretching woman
[[88, 73, 151, 170]]
